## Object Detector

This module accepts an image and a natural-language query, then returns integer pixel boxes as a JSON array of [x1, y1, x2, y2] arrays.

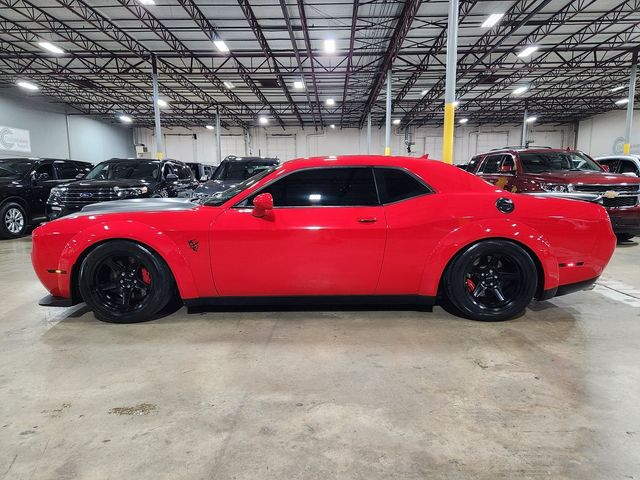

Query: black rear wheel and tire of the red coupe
[[442, 240, 538, 322]]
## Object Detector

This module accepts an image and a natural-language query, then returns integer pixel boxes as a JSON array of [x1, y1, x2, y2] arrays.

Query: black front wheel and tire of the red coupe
[[79, 240, 175, 323]]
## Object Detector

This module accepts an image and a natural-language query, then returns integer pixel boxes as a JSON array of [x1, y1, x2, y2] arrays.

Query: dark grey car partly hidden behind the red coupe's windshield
[[196, 156, 280, 196]]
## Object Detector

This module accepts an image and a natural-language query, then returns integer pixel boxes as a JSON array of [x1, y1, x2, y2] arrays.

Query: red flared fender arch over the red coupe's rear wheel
[[420, 219, 560, 296]]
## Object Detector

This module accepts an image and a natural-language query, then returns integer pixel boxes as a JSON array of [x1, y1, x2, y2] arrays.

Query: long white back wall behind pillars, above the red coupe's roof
[[135, 125, 575, 164]]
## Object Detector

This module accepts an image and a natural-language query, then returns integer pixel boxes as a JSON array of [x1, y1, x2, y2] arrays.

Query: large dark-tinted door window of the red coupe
[[251, 167, 378, 207]]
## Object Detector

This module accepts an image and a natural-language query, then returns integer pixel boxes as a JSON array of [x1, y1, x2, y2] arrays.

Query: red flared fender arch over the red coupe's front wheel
[[58, 221, 199, 298]]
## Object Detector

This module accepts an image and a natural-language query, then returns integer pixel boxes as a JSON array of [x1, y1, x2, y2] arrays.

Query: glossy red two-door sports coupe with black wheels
[[33, 156, 616, 323]]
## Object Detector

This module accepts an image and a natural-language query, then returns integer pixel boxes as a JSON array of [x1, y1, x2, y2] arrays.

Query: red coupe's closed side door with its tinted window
[[211, 167, 386, 296]]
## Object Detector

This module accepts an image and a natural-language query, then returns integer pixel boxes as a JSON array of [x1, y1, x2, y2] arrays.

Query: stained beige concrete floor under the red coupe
[[0, 238, 640, 480]]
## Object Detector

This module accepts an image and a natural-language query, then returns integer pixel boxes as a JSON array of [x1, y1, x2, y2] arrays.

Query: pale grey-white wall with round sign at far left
[[0, 94, 135, 163]]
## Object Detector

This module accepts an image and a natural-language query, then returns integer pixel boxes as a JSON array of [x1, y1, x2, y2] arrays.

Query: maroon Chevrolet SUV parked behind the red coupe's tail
[[467, 148, 640, 241]]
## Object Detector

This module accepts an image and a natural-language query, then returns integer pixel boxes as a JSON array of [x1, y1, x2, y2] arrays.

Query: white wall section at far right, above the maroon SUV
[[578, 110, 640, 157]]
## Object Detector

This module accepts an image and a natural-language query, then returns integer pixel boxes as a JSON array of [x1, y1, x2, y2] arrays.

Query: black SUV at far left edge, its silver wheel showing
[[0, 158, 93, 238]]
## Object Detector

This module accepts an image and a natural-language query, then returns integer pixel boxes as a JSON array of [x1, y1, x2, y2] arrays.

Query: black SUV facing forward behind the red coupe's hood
[[47, 158, 198, 220]]
